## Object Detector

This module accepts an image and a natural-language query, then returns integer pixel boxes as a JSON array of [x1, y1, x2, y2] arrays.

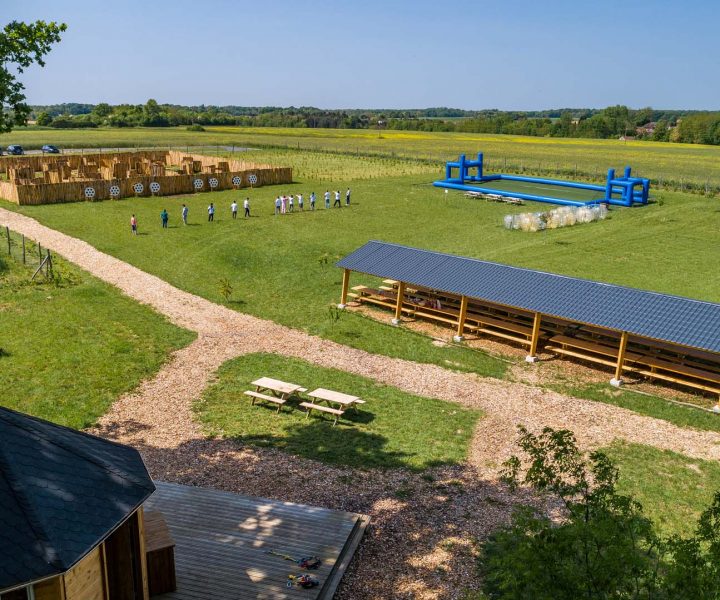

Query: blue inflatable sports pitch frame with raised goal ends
[[433, 152, 650, 206]]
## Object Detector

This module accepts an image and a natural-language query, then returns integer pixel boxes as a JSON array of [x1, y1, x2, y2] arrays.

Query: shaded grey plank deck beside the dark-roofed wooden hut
[[145, 481, 369, 600]]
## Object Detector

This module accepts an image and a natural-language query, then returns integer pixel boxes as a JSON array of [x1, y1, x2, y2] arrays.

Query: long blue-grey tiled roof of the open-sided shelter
[[337, 241, 720, 352]]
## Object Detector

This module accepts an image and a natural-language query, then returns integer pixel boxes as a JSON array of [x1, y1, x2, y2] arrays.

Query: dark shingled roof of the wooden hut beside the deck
[[0, 407, 155, 591]]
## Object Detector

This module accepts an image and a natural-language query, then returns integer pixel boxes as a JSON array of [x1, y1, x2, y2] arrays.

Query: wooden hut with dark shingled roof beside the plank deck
[[0, 408, 160, 600]]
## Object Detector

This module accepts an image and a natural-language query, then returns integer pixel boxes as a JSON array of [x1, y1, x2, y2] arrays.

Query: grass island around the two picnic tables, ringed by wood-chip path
[[195, 354, 480, 469]]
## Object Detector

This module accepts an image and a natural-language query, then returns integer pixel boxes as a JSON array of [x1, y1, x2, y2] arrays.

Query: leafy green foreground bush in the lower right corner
[[480, 428, 720, 600]]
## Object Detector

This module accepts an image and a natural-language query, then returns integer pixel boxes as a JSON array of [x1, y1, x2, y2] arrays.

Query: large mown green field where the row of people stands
[[5, 149, 720, 418]]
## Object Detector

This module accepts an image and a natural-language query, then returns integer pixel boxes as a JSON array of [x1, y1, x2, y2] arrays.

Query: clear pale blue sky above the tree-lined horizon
[[5, 0, 720, 110]]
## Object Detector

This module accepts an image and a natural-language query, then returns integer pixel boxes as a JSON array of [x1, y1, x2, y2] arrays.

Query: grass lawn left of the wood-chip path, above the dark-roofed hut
[[0, 239, 194, 428]]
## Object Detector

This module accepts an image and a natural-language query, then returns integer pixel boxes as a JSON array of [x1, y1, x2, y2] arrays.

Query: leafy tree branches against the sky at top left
[[0, 21, 67, 133]]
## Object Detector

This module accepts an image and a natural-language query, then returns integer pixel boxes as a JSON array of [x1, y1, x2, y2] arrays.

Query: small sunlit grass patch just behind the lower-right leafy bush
[[605, 442, 720, 535]]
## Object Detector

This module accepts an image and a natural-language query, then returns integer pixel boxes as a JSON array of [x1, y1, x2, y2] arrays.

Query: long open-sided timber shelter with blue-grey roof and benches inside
[[337, 241, 720, 404]]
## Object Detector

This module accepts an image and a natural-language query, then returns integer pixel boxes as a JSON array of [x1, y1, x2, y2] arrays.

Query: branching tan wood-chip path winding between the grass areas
[[0, 209, 720, 598]]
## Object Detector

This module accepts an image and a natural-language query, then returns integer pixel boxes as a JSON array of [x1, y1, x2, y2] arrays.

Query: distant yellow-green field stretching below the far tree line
[[5, 127, 720, 190]]
